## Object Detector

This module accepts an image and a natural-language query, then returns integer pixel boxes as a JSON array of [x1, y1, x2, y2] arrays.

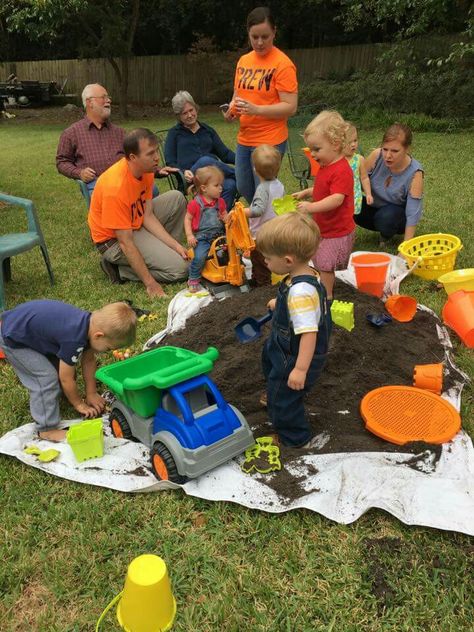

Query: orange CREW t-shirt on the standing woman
[[234, 46, 298, 147]]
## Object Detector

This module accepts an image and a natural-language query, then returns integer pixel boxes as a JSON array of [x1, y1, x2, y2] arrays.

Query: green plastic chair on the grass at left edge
[[0, 193, 54, 311]]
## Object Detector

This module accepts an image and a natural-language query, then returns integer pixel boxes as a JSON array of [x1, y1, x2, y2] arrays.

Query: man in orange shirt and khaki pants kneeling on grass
[[88, 128, 188, 297]]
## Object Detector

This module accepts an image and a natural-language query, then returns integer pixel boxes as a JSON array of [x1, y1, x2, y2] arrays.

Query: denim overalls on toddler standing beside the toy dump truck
[[262, 274, 332, 447]]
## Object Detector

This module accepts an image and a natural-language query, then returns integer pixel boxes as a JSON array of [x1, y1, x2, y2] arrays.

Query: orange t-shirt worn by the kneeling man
[[87, 158, 154, 244]]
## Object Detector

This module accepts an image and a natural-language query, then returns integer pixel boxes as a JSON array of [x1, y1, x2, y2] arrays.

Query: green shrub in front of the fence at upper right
[[300, 39, 474, 131]]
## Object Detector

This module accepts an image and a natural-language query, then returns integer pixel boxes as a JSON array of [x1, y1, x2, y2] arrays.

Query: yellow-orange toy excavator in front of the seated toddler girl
[[192, 202, 255, 294]]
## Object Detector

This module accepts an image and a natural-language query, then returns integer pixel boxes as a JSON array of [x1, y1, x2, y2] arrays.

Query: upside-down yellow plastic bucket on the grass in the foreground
[[117, 555, 176, 632]]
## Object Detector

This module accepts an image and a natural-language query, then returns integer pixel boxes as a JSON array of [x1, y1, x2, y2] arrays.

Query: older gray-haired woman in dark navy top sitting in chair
[[165, 90, 237, 210]]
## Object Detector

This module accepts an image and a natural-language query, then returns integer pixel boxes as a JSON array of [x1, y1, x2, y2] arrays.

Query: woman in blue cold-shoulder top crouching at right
[[354, 123, 423, 241]]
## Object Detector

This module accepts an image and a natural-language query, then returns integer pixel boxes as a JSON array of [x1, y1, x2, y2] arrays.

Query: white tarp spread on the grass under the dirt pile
[[0, 252, 474, 535]]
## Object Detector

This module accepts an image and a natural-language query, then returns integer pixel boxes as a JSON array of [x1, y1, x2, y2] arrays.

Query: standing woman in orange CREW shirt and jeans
[[224, 7, 298, 204]]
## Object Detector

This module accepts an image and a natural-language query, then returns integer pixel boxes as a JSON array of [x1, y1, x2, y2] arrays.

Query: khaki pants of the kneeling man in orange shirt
[[103, 191, 188, 283]]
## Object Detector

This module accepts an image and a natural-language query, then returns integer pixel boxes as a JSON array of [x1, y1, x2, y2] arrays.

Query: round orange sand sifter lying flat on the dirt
[[360, 386, 461, 445]]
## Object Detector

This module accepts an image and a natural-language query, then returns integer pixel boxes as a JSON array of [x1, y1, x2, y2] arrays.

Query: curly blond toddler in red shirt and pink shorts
[[293, 110, 355, 301]]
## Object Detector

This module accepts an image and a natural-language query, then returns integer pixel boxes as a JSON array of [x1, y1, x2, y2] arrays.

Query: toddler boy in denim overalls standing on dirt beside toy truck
[[257, 213, 332, 448]]
